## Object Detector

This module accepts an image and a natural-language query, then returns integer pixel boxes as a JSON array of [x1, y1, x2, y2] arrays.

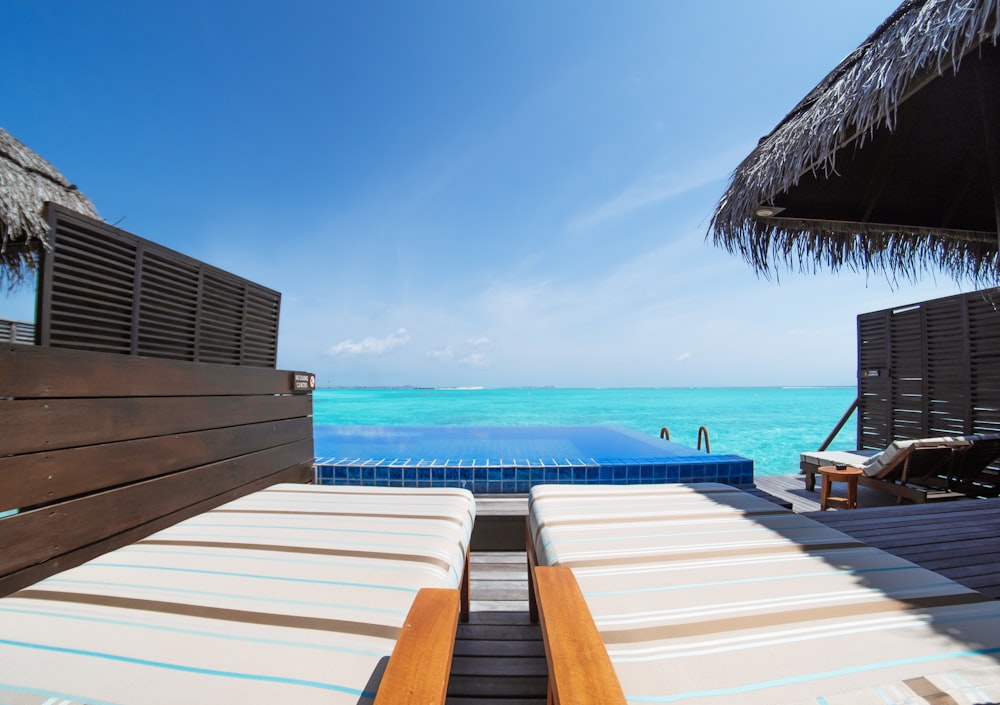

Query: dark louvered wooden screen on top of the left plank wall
[[37, 203, 281, 368]]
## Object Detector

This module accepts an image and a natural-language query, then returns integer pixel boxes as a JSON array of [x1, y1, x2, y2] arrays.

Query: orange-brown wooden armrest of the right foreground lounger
[[535, 566, 625, 705]]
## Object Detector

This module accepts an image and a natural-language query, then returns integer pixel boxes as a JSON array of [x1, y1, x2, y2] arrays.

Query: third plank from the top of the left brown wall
[[0, 418, 312, 511]]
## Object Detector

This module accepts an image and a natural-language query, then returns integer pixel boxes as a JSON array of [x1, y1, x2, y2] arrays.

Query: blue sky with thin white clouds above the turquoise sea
[[0, 0, 972, 386]]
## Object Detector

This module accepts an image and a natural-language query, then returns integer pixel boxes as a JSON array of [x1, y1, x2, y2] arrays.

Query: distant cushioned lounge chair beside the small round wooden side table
[[799, 436, 972, 502]]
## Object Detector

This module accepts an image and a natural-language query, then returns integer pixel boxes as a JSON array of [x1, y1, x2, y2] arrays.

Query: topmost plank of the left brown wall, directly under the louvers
[[0, 345, 306, 399]]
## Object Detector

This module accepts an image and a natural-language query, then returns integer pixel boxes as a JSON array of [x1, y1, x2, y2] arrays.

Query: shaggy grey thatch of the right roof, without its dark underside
[[709, 0, 1000, 283]]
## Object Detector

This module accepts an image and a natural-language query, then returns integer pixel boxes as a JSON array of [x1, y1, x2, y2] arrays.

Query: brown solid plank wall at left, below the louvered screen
[[0, 345, 313, 595]]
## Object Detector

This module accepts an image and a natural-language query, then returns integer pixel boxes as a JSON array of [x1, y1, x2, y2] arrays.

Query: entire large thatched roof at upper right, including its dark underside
[[709, 0, 1000, 283]]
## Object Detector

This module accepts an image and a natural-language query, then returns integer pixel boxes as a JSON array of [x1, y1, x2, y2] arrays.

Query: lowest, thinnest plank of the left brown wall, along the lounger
[[0, 461, 313, 596]]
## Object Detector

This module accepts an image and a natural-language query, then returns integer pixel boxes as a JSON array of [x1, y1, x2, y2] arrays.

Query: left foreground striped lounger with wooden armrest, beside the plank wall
[[0, 484, 475, 705]]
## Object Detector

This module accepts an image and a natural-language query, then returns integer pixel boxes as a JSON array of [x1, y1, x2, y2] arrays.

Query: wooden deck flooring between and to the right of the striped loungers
[[447, 484, 1000, 705]]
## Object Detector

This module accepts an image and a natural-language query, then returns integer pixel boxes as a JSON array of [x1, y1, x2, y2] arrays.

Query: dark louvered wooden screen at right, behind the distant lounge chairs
[[858, 288, 1000, 448]]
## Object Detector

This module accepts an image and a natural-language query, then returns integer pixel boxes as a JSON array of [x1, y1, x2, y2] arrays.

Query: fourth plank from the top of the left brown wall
[[0, 438, 312, 575]]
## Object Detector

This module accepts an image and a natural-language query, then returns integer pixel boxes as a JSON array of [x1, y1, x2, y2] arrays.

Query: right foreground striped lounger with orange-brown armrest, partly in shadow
[[528, 484, 1000, 705]]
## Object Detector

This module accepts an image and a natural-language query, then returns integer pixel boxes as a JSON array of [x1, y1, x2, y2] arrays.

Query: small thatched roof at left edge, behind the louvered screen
[[0, 128, 97, 291]]
